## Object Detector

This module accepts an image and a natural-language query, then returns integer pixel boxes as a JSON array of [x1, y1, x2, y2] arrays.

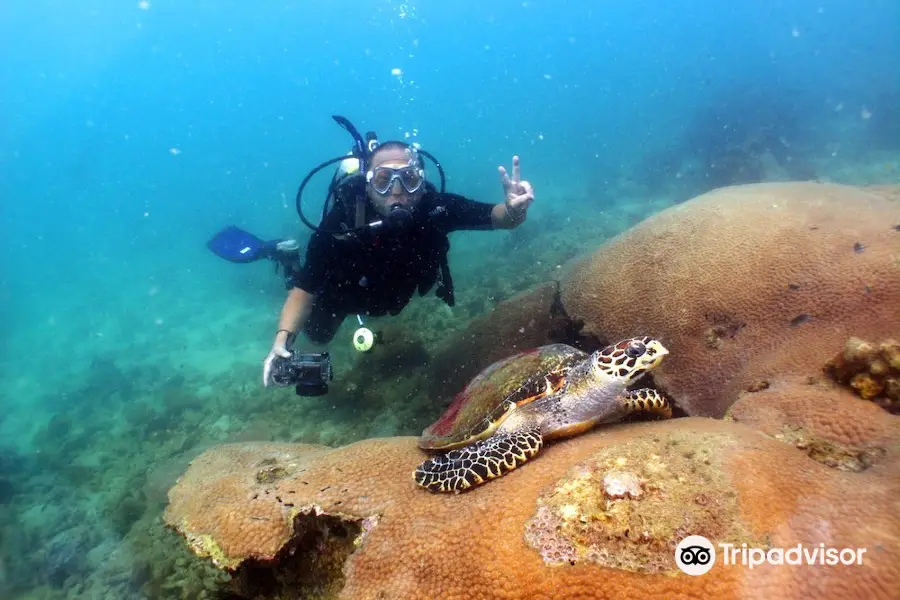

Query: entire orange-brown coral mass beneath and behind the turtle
[[165, 183, 900, 599]]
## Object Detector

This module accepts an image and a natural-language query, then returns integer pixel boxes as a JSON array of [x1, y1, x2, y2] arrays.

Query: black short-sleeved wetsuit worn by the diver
[[288, 178, 493, 343]]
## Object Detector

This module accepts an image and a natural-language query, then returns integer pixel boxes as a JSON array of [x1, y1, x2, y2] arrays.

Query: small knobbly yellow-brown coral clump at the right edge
[[825, 337, 900, 414]]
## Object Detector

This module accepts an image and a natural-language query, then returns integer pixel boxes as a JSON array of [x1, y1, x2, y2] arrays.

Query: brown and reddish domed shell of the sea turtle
[[419, 344, 589, 450]]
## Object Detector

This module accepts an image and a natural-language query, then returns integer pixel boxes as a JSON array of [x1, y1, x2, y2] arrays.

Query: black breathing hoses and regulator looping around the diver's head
[[296, 115, 446, 235]]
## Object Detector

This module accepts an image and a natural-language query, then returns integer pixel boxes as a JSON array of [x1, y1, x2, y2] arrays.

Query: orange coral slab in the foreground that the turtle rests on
[[165, 413, 900, 600]]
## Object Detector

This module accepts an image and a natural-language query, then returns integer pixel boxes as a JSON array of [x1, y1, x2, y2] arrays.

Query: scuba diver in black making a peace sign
[[210, 116, 534, 393]]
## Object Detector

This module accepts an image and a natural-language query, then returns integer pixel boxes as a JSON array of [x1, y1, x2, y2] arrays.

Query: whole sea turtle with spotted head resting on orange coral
[[413, 337, 672, 492]]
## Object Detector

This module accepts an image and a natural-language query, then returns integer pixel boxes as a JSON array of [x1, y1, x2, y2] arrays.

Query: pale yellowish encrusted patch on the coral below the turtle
[[525, 430, 766, 575]]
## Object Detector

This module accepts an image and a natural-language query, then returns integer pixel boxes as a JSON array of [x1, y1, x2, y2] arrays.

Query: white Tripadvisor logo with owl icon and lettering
[[675, 535, 866, 575]]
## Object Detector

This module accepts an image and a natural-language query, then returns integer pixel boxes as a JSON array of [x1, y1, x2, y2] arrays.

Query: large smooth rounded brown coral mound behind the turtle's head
[[561, 183, 900, 417]]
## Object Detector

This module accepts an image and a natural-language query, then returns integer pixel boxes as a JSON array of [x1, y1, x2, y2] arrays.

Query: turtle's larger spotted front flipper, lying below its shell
[[413, 428, 544, 492]]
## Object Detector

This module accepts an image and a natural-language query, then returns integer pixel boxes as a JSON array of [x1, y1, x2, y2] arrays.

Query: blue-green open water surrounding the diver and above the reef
[[0, 0, 900, 598]]
